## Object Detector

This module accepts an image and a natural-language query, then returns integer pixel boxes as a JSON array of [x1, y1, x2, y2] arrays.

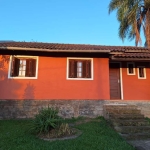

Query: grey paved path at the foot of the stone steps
[[128, 140, 150, 150]]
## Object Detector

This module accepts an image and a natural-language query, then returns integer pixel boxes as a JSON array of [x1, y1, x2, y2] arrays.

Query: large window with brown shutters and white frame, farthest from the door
[[9, 56, 38, 79]]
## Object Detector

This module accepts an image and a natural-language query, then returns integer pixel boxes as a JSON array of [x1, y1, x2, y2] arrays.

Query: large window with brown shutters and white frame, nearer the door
[[67, 58, 93, 80]]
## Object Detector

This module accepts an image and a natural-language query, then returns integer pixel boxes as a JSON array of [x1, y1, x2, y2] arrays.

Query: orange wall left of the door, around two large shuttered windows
[[0, 57, 110, 100]]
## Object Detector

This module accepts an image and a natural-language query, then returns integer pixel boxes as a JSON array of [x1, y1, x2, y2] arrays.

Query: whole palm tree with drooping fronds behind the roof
[[109, 0, 150, 47]]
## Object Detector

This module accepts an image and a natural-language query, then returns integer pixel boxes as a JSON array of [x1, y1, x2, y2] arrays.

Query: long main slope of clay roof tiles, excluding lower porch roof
[[0, 42, 150, 52]]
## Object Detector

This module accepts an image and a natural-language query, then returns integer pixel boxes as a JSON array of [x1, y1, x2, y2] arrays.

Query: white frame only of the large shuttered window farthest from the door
[[8, 55, 39, 79]]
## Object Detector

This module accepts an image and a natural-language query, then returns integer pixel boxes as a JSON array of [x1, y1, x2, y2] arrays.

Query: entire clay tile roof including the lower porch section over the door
[[0, 42, 150, 58]]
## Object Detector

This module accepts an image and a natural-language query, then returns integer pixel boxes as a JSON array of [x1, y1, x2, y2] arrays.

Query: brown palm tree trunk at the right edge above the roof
[[146, 8, 150, 48]]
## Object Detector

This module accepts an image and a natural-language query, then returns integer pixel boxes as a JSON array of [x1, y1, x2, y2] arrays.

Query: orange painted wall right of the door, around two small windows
[[122, 62, 150, 100]]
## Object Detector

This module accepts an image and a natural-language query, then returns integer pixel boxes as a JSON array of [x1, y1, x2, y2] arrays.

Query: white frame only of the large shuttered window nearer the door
[[66, 57, 94, 80]]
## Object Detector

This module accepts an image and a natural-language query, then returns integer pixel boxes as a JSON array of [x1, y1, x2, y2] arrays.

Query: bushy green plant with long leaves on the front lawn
[[31, 107, 63, 134]]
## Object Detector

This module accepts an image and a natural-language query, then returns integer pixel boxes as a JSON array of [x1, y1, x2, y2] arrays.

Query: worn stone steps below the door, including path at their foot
[[104, 105, 150, 150]]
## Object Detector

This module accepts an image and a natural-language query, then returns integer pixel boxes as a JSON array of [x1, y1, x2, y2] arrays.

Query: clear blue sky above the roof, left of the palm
[[0, 0, 134, 46]]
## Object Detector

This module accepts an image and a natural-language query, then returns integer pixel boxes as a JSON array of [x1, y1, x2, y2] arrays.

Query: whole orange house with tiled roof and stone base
[[0, 42, 150, 118]]
